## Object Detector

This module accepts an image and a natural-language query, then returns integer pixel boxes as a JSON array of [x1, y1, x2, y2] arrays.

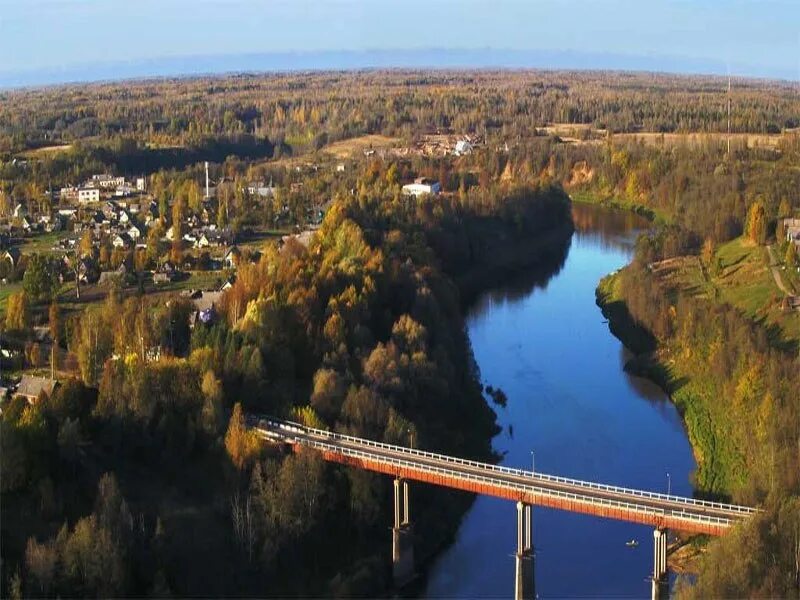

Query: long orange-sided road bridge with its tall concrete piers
[[246, 415, 757, 598]]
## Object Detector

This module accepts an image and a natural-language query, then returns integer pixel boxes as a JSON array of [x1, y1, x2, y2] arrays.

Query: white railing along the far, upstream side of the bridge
[[250, 417, 758, 516]]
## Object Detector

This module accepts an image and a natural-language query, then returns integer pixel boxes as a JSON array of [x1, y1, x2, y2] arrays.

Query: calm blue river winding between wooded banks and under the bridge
[[425, 204, 695, 598]]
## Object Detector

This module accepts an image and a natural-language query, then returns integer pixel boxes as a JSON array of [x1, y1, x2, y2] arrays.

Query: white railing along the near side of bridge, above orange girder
[[257, 425, 732, 527]]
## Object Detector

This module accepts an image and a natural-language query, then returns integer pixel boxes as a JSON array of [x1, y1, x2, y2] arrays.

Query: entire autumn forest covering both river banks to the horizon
[[0, 71, 800, 597]]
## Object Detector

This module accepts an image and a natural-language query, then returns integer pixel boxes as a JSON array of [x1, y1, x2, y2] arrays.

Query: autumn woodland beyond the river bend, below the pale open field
[[470, 136, 800, 248]]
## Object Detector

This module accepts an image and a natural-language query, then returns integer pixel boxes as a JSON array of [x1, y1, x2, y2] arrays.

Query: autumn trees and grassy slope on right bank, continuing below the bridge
[[601, 250, 800, 598]]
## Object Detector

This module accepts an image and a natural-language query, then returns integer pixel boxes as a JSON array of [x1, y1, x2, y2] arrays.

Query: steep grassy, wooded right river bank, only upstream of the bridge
[[597, 261, 798, 504]]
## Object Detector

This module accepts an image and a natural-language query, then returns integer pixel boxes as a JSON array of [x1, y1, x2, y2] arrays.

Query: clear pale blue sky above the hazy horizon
[[0, 0, 800, 85]]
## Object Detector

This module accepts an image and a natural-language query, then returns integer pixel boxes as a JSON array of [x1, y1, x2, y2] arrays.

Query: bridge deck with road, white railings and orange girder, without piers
[[252, 416, 757, 535]]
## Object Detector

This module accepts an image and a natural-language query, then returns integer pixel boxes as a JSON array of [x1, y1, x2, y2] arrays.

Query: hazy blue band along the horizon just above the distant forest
[[0, 46, 800, 91]]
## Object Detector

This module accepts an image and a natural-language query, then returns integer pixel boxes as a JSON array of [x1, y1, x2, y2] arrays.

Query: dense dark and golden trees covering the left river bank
[[2, 176, 571, 596]]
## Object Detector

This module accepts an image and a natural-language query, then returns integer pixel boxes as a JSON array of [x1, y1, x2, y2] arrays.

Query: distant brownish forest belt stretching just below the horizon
[[0, 71, 800, 157]]
